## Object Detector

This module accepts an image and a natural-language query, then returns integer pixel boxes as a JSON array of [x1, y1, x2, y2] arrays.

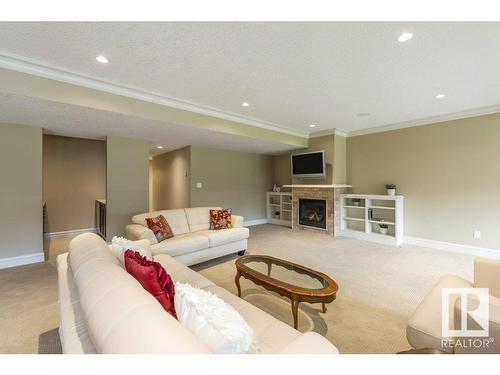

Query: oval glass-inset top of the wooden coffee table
[[240, 255, 331, 290]]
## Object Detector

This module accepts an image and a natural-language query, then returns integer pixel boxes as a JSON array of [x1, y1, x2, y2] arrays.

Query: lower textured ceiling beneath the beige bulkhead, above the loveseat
[[0, 93, 298, 154]]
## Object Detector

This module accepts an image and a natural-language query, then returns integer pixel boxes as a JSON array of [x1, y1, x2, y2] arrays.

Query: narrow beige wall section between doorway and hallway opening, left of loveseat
[[106, 137, 149, 241]]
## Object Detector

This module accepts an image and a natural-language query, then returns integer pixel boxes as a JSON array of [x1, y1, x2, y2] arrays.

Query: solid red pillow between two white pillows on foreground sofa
[[124, 250, 177, 319]]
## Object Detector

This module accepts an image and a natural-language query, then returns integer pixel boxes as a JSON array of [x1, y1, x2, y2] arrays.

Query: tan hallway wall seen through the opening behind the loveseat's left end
[[151, 147, 191, 210]]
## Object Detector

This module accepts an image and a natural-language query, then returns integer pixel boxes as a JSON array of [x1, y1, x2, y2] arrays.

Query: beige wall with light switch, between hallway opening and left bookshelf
[[191, 146, 273, 221]]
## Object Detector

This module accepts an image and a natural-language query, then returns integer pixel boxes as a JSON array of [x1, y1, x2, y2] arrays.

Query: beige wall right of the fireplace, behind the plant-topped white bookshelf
[[347, 114, 500, 249]]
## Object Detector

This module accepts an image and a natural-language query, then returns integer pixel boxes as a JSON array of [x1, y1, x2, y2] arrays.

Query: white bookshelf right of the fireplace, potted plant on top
[[336, 194, 404, 246]]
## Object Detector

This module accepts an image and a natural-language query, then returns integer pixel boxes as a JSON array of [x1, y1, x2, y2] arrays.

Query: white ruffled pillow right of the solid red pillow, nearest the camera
[[174, 282, 256, 354]]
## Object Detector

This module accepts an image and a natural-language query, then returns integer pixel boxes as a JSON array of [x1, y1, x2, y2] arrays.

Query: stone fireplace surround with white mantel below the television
[[283, 185, 351, 236]]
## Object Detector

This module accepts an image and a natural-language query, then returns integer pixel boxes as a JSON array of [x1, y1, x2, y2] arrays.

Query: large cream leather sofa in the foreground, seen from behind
[[57, 233, 338, 354]]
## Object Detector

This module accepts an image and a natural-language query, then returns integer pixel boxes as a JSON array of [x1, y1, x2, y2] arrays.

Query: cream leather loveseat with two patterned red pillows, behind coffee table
[[126, 207, 249, 266]]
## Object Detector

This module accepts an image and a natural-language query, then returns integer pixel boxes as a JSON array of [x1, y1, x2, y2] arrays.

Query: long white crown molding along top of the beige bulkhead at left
[[0, 53, 308, 138]]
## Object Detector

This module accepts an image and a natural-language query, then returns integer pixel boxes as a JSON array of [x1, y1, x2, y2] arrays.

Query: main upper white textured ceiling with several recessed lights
[[0, 22, 500, 137]]
